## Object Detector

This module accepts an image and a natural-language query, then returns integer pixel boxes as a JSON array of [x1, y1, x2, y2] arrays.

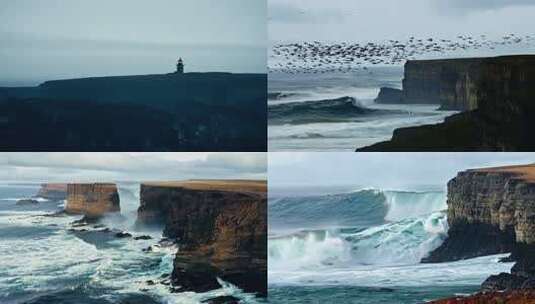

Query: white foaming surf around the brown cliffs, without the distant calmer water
[[0, 185, 256, 304]]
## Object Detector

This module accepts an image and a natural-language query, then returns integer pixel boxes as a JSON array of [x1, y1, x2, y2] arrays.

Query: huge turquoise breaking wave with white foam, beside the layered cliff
[[268, 190, 448, 269]]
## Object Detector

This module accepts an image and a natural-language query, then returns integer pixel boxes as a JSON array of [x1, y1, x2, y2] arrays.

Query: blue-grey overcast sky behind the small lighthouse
[[0, 0, 267, 85]]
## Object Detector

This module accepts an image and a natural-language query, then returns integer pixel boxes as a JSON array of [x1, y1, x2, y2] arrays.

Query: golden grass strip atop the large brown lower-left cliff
[[143, 179, 267, 193]]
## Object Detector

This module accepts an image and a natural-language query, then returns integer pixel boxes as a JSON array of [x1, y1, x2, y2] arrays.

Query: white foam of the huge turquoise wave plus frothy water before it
[[268, 191, 512, 287]]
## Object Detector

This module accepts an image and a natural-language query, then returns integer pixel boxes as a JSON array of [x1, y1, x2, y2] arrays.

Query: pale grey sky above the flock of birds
[[268, 0, 535, 42]]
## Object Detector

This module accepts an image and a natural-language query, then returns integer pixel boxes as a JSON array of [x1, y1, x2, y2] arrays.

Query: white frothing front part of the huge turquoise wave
[[268, 212, 447, 269]]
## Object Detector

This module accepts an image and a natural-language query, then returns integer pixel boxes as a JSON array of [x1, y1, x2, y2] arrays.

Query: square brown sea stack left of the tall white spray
[[65, 183, 121, 218]]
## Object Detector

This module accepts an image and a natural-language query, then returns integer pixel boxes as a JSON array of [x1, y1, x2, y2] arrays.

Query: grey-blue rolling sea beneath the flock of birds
[[268, 67, 456, 151]]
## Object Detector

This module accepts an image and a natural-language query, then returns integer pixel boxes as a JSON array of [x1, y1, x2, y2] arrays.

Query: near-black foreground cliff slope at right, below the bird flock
[[357, 55, 535, 151]]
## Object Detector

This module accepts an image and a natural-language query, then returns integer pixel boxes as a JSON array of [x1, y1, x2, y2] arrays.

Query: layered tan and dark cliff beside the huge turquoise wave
[[422, 165, 535, 290]]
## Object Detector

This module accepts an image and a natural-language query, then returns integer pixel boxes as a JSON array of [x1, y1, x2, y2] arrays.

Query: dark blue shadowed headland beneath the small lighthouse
[[0, 73, 267, 151]]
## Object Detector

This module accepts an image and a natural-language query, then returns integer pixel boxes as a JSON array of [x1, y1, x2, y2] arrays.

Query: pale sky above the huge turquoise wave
[[268, 152, 535, 190]]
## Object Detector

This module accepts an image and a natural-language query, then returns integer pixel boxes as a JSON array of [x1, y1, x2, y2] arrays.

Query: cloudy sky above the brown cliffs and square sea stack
[[0, 152, 267, 182]]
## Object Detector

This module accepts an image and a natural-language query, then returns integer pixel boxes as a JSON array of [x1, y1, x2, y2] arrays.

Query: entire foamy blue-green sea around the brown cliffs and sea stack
[[0, 183, 257, 304]]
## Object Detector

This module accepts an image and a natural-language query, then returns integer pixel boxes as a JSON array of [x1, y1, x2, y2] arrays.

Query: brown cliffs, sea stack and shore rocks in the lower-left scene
[[26, 180, 267, 303]]
